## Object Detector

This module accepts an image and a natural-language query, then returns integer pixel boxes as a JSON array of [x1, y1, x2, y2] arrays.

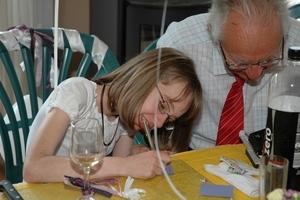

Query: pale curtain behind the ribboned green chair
[[0, 0, 54, 113]]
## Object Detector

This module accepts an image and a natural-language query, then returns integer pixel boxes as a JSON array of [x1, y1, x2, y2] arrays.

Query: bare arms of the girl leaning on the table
[[23, 108, 171, 182]]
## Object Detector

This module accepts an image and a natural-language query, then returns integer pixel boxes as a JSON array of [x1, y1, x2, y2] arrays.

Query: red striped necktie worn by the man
[[216, 76, 245, 146]]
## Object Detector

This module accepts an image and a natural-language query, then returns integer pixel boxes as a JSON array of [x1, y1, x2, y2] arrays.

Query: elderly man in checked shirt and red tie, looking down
[[157, 0, 300, 149]]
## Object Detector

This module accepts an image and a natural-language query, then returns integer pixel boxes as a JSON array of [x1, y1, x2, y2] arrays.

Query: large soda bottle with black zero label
[[263, 46, 300, 190]]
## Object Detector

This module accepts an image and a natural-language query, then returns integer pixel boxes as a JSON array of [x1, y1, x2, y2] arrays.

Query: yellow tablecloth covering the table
[[0, 144, 258, 200]]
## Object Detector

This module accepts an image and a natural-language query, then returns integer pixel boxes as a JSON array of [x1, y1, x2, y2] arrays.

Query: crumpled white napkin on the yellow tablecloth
[[204, 157, 259, 197]]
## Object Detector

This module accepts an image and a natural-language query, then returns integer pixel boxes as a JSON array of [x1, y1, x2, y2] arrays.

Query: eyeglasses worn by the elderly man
[[220, 38, 284, 70]]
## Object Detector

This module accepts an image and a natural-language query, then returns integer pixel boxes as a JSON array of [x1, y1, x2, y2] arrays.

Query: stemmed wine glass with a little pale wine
[[70, 118, 103, 200]]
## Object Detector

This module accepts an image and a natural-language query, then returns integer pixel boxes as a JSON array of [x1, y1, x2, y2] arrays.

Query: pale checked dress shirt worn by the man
[[157, 13, 300, 149]]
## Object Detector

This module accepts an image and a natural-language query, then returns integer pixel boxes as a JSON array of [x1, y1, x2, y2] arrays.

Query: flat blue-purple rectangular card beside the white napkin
[[200, 183, 233, 198]]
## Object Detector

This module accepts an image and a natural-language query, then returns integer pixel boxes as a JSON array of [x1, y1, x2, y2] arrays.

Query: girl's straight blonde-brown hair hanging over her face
[[94, 48, 202, 152]]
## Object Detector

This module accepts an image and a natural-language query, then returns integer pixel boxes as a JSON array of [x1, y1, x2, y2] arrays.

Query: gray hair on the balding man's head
[[208, 0, 290, 42]]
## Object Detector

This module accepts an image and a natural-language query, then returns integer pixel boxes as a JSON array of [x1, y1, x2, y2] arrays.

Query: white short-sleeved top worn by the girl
[[26, 77, 128, 156]]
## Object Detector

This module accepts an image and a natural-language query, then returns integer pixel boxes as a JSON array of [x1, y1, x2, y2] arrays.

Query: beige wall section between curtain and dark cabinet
[[58, 0, 90, 34]]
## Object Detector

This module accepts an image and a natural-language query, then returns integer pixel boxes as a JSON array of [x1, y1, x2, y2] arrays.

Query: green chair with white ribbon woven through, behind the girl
[[0, 26, 119, 183]]
